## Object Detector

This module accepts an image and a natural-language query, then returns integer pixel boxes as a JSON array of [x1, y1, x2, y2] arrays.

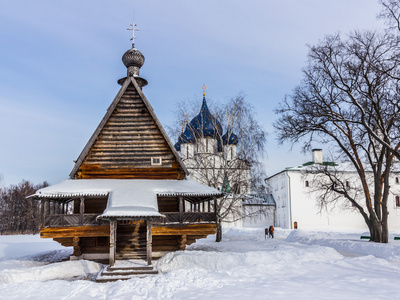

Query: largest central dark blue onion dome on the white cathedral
[[190, 96, 222, 138]]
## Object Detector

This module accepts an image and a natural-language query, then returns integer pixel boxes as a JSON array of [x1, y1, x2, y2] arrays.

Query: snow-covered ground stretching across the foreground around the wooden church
[[0, 228, 400, 300]]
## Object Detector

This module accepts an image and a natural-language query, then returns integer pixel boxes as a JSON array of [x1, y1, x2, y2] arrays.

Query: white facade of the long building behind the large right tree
[[266, 152, 400, 231]]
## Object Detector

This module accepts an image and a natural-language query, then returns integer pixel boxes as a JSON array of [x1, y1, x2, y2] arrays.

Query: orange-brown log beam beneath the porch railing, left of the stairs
[[40, 225, 110, 238]]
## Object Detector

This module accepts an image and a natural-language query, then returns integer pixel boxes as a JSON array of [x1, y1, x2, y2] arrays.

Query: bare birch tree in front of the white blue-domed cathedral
[[169, 95, 266, 241]]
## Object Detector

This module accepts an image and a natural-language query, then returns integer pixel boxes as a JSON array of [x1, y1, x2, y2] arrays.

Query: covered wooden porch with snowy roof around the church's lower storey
[[31, 179, 221, 265]]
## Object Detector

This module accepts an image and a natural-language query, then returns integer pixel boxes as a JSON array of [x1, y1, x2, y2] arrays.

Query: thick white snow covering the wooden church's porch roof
[[32, 178, 221, 218]]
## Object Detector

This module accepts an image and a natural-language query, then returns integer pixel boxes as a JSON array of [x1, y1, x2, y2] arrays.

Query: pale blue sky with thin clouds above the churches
[[0, 0, 383, 184]]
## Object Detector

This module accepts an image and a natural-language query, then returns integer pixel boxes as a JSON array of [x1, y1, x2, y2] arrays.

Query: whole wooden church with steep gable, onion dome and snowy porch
[[31, 24, 221, 266]]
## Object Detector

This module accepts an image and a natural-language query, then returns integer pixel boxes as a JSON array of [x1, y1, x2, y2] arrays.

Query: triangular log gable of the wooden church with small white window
[[70, 76, 189, 179]]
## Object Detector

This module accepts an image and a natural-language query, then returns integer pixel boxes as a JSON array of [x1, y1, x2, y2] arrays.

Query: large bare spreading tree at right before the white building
[[274, 31, 400, 243]]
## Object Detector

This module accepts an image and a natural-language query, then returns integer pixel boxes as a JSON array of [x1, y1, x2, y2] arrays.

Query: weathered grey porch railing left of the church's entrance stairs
[[43, 214, 101, 227]]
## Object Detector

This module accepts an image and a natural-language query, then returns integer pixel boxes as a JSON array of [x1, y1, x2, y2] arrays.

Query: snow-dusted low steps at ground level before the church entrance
[[96, 260, 158, 283]]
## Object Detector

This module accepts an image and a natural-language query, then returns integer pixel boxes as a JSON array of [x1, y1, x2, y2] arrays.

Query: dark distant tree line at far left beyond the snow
[[0, 180, 49, 235]]
